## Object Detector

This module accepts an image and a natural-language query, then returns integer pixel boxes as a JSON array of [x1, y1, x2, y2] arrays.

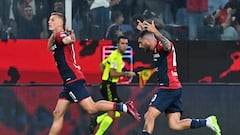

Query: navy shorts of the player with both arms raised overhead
[[149, 88, 183, 113]]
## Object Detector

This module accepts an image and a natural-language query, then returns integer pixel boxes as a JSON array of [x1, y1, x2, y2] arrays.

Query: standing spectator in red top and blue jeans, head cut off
[[187, 0, 208, 40]]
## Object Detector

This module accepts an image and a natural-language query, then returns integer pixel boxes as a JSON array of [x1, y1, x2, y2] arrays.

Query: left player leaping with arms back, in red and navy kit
[[48, 12, 140, 135]]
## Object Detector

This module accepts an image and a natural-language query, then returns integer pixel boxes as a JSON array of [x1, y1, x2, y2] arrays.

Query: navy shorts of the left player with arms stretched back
[[59, 80, 90, 103]]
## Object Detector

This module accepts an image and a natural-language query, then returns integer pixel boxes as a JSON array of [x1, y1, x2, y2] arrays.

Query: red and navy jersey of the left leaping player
[[53, 31, 85, 84]]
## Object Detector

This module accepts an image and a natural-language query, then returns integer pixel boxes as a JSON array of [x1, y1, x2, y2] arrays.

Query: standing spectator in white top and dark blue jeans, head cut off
[[90, 0, 120, 39]]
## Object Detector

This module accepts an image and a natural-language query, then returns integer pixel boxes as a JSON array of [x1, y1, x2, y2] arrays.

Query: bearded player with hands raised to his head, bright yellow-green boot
[[137, 21, 221, 135]]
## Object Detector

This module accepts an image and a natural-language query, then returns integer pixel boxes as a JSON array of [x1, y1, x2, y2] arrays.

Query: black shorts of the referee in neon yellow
[[100, 81, 121, 103]]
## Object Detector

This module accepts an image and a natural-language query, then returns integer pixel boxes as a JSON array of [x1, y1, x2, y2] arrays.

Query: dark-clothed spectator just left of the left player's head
[[15, 5, 42, 39]]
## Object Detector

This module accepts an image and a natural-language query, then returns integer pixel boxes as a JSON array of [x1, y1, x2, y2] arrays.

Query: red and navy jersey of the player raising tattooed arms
[[153, 41, 182, 89]]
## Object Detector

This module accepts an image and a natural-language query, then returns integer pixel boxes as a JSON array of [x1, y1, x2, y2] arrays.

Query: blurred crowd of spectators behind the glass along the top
[[0, 0, 240, 40]]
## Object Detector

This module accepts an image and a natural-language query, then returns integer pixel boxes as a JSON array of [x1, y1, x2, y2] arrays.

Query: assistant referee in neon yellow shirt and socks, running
[[89, 36, 136, 135]]
